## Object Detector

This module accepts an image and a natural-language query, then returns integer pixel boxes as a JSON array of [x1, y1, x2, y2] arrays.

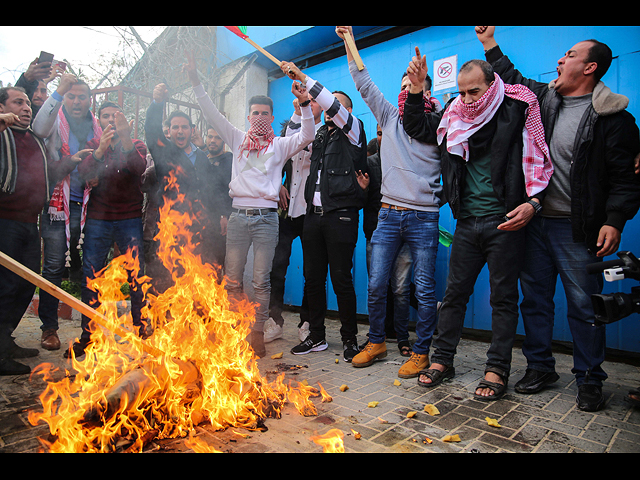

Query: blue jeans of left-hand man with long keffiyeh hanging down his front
[[38, 202, 82, 330]]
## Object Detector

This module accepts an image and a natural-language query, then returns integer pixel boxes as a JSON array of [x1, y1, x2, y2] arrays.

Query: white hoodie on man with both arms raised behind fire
[[193, 85, 315, 209]]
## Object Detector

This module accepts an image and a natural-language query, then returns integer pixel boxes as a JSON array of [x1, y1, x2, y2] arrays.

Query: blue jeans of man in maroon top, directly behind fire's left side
[[81, 218, 144, 341]]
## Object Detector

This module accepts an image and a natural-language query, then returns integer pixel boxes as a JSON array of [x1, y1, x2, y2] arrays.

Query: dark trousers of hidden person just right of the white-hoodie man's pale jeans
[[269, 215, 309, 327]]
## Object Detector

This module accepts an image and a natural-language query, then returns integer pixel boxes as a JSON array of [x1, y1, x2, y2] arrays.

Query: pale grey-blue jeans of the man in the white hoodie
[[225, 212, 279, 332]]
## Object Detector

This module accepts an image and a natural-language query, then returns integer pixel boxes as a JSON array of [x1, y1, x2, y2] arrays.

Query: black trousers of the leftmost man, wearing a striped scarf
[[0, 219, 40, 358]]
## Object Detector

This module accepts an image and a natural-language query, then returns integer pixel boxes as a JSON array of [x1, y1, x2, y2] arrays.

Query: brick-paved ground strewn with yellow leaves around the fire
[[0, 312, 640, 453]]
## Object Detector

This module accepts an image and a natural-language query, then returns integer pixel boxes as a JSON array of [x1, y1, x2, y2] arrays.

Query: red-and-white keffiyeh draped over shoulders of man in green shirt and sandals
[[437, 74, 554, 197]]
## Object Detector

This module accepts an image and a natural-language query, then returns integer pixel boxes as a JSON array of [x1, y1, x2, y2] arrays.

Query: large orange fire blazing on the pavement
[[29, 173, 330, 452]]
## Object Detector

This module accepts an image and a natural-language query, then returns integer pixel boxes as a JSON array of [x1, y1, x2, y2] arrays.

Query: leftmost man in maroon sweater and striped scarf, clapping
[[0, 87, 82, 375]]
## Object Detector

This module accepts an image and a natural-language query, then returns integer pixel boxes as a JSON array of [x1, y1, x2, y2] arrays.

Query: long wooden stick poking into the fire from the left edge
[[0, 252, 164, 357]]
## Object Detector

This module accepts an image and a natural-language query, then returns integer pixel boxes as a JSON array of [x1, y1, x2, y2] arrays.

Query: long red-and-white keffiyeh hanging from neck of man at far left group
[[48, 108, 102, 268]]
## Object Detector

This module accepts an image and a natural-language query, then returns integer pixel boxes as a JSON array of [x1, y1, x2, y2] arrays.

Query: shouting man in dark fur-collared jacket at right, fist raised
[[475, 25, 640, 412]]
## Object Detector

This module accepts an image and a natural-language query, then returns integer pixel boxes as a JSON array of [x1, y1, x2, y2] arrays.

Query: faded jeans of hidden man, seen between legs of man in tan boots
[[367, 241, 413, 342]]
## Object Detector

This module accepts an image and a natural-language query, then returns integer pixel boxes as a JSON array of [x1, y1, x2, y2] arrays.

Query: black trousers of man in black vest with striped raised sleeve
[[303, 208, 360, 343]]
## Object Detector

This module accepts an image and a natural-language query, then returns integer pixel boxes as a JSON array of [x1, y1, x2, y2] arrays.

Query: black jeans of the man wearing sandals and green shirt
[[431, 215, 525, 376]]
